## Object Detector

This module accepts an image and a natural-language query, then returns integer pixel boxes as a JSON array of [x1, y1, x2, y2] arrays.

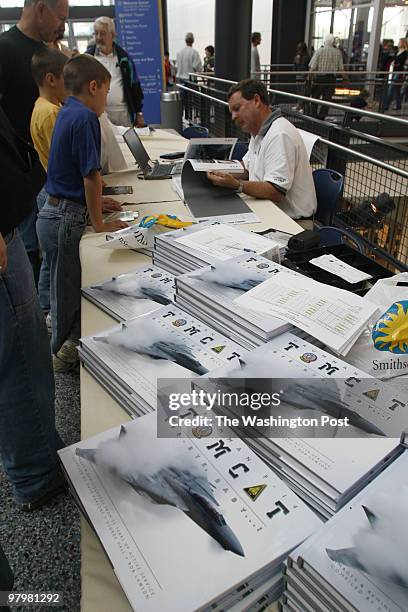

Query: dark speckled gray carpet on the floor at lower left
[[0, 374, 81, 612]]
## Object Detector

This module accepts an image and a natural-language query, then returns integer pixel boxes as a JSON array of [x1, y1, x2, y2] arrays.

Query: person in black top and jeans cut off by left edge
[[0, 108, 66, 511]]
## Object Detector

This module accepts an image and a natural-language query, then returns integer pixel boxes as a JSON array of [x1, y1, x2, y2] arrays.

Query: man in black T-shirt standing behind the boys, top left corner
[[0, 0, 68, 272]]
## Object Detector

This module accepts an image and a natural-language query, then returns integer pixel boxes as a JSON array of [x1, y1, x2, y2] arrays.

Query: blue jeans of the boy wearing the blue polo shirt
[[37, 199, 86, 355]]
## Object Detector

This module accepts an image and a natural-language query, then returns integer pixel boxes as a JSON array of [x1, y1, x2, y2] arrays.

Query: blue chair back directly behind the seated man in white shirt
[[313, 168, 344, 225]]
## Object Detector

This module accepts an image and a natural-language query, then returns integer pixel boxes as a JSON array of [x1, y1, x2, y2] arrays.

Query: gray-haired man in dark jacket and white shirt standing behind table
[[86, 17, 145, 127]]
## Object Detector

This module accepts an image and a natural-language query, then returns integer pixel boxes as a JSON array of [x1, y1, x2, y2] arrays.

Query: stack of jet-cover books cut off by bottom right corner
[[281, 451, 408, 612]]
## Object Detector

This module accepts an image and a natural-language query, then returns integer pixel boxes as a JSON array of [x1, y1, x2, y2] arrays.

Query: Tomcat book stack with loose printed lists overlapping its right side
[[175, 254, 298, 349]]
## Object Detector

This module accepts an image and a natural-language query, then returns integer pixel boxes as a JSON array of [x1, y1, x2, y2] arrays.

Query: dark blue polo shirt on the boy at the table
[[45, 96, 101, 204]]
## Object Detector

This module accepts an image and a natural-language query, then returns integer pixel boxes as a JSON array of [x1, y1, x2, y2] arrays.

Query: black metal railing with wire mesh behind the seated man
[[180, 77, 408, 270]]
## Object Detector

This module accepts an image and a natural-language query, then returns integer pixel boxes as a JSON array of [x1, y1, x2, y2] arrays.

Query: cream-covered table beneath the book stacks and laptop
[[80, 131, 302, 612]]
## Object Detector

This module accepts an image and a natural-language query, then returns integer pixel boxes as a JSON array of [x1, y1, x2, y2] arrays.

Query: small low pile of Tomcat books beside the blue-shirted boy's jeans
[[82, 265, 175, 321]]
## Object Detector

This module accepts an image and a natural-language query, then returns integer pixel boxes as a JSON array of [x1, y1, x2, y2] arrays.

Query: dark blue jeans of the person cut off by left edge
[[0, 230, 63, 503]]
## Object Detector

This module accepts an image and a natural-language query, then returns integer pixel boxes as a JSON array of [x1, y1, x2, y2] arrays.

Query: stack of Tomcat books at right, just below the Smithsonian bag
[[198, 333, 407, 518]]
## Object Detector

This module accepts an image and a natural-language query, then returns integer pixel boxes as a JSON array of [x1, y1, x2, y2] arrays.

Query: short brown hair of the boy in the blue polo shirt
[[64, 53, 111, 96]]
